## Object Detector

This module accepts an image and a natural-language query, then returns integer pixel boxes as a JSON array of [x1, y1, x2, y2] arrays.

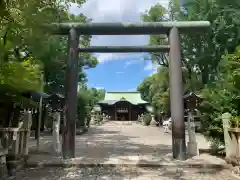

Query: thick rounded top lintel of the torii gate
[[48, 21, 210, 35]]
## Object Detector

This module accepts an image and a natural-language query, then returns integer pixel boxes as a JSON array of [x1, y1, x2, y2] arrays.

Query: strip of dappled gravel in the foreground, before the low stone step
[[10, 167, 239, 180]]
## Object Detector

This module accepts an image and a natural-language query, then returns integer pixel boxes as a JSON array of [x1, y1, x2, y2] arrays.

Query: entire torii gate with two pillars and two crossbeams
[[48, 21, 210, 160]]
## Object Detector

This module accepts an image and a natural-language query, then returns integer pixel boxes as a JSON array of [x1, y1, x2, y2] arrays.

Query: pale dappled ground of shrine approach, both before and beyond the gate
[[19, 122, 238, 180]]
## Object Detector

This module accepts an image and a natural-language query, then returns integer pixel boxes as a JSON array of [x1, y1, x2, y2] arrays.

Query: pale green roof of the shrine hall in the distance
[[99, 92, 148, 105]]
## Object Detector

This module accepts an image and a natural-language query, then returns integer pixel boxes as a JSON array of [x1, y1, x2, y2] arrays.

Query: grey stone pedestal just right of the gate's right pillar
[[187, 112, 199, 157]]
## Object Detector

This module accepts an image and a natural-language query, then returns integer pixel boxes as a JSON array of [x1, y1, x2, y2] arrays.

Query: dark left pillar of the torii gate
[[63, 28, 79, 159]]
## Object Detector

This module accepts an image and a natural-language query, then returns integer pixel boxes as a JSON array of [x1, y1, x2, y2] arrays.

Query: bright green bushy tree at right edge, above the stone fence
[[200, 47, 240, 143]]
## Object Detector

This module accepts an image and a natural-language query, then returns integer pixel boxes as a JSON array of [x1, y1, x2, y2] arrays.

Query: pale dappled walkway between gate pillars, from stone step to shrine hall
[[29, 121, 211, 164]]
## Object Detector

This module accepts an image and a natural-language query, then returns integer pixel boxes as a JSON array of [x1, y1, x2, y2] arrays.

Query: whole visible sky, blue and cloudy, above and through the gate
[[70, 0, 168, 91]]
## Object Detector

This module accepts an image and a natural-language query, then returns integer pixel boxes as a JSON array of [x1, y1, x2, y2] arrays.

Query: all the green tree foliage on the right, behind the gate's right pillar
[[138, 0, 240, 146]]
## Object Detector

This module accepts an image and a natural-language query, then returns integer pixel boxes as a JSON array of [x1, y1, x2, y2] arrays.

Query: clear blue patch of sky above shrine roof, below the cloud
[[87, 54, 156, 91]]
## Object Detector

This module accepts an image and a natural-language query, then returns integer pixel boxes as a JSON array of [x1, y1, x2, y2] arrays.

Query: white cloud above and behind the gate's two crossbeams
[[70, 0, 169, 62]]
